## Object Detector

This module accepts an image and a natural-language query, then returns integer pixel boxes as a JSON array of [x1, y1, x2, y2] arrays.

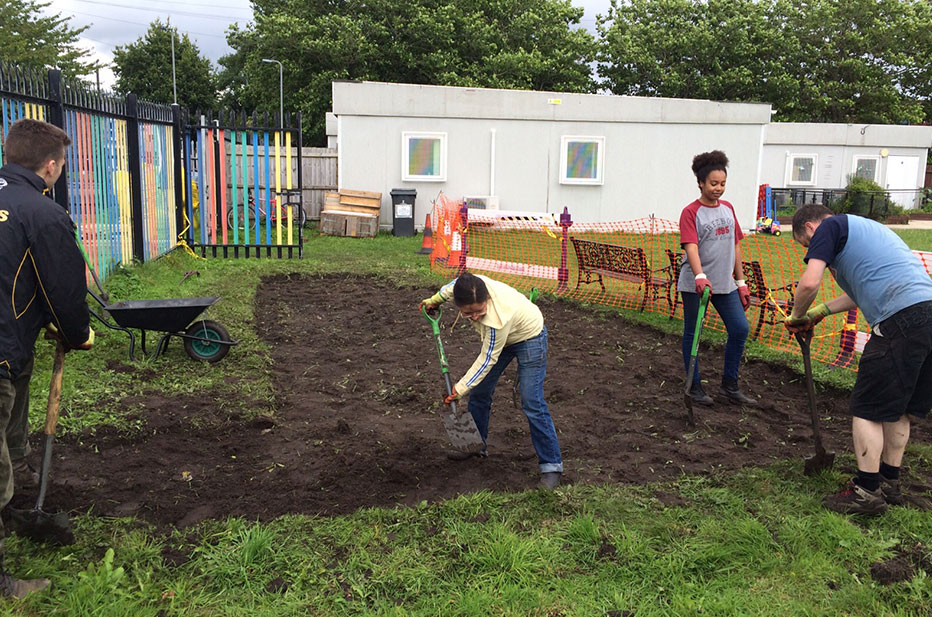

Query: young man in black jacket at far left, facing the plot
[[0, 119, 94, 597]]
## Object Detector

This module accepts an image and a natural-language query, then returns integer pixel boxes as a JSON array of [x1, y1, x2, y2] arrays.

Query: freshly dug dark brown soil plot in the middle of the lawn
[[17, 276, 930, 528]]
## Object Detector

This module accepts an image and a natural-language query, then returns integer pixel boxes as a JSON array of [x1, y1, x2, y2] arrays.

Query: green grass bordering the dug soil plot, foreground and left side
[[9, 226, 932, 617]]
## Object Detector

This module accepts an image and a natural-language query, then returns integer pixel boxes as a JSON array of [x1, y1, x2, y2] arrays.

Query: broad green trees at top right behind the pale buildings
[[598, 0, 932, 123]]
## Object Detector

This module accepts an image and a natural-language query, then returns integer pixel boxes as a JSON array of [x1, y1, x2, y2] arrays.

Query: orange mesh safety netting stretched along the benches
[[430, 193, 932, 370]]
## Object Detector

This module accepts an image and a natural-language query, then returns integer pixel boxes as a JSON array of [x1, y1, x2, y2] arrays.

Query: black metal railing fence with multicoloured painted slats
[[0, 61, 306, 277]]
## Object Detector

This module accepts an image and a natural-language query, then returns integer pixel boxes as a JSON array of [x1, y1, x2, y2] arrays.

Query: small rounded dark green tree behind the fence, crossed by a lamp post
[[113, 20, 217, 111]]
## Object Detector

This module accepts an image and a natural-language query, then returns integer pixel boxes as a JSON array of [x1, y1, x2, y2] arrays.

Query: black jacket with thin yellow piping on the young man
[[0, 163, 89, 379]]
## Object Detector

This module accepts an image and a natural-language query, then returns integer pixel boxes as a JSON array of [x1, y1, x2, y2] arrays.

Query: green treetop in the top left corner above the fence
[[0, 0, 100, 77]]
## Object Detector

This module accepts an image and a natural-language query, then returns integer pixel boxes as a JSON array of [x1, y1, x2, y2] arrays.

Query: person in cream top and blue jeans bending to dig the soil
[[421, 272, 563, 489]]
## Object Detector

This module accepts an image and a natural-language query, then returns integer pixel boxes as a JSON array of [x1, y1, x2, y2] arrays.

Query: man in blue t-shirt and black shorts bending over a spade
[[786, 204, 932, 514]]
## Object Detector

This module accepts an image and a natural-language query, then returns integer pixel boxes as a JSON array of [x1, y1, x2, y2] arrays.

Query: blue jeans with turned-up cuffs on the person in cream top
[[469, 327, 563, 473]]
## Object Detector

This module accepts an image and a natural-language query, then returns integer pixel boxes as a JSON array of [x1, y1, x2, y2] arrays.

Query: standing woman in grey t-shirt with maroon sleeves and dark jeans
[[676, 150, 757, 405]]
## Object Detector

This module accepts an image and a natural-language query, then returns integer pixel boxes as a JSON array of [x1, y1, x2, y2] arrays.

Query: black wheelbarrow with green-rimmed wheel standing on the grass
[[88, 289, 238, 362]]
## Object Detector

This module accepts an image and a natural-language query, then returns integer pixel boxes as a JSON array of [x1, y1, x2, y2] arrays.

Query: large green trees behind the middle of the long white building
[[219, 0, 595, 143]]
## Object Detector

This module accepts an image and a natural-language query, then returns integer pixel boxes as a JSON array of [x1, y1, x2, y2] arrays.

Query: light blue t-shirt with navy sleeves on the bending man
[[804, 214, 932, 326]]
